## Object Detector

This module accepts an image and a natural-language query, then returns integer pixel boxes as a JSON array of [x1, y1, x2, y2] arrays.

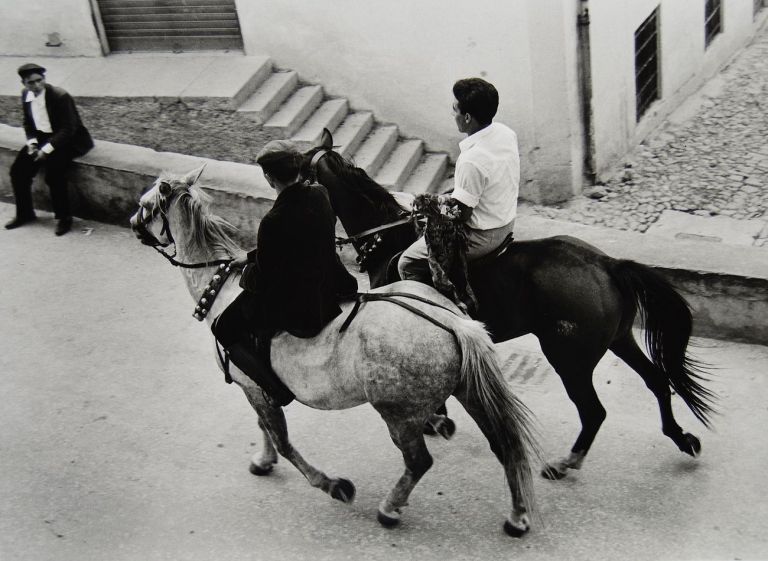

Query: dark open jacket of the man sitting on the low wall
[[21, 84, 93, 157]]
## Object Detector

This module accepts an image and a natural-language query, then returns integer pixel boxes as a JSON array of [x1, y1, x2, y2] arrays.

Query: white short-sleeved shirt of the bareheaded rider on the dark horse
[[451, 123, 520, 230]]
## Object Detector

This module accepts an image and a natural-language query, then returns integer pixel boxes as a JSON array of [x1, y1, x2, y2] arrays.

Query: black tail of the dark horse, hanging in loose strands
[[611, 260, 715, 427]]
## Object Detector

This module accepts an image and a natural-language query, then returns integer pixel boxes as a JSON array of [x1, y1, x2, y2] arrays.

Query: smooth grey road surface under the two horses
[[0, 204, 768, 561]]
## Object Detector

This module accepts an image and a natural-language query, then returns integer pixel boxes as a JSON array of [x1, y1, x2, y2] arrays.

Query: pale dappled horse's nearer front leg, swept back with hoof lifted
[[243, 385, 355, 503]]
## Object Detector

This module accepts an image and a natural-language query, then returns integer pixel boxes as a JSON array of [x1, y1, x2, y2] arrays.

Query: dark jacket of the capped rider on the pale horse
[[242, 183, 357, 337]]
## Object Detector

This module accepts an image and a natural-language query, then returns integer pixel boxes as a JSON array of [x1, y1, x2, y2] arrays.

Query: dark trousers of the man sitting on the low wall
[[11, 133, 73, 219]]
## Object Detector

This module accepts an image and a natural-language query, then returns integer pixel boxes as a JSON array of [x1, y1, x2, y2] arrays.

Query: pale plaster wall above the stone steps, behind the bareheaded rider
[[237, 0, 580, 201]]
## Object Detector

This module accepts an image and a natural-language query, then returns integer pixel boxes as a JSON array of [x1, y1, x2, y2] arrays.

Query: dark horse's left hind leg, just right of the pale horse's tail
[[540, 337, 606, 479]]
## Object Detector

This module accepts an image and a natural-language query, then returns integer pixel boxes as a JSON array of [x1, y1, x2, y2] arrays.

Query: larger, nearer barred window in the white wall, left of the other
[[635, 8, 661, 121]]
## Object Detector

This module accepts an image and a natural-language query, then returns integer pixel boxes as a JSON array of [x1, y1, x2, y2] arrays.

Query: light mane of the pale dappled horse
[[165, 177, 242, 257]]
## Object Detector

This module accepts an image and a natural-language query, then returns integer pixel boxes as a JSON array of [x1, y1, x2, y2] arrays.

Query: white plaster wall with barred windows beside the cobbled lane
[[590, 0, 766, 174]]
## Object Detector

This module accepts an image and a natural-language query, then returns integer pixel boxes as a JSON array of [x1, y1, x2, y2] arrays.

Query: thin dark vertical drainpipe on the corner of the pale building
[[576, 0, 597, 185]]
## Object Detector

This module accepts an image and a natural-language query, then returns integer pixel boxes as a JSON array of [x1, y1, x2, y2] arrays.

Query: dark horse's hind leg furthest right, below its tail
[[610, 331, 701, 458]]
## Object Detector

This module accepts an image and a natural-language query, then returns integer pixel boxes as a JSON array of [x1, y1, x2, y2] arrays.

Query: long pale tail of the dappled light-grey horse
[[454, 319, 542, 512]]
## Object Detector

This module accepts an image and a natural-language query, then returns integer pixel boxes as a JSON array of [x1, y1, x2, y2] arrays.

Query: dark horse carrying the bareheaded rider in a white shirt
[[304, 130, 715, 479]]
